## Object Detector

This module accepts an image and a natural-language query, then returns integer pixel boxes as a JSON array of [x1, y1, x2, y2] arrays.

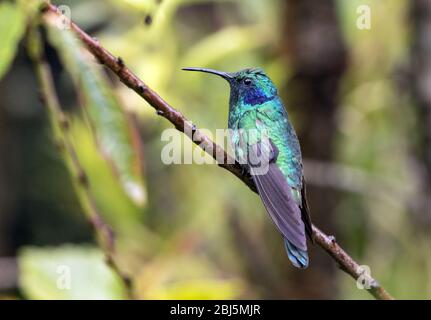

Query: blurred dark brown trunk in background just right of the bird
[[282, 0, 347, 299]]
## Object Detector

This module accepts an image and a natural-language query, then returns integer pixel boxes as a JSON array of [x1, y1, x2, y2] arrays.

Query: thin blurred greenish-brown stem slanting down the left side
[[29, 28, 133, 298]]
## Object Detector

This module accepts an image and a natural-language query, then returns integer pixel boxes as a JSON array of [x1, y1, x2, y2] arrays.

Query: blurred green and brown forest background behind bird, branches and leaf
[[0, 0, 431, 299]]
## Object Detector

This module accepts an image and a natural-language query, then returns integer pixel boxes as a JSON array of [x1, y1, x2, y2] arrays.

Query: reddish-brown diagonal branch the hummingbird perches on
[[44, 4, 393, 300]]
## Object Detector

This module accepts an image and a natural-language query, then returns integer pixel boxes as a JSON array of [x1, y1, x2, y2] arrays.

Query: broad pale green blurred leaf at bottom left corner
[[18, 245, 125, 299]]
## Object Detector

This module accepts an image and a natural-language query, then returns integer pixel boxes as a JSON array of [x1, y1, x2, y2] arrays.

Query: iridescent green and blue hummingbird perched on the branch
[[183, 68, 312, 268]]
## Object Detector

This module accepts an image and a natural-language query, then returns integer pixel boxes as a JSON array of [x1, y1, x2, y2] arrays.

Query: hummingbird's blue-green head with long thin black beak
[[183, 68, 277, 106]]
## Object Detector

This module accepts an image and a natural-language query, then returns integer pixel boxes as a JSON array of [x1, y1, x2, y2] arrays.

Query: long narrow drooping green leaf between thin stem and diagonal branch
[[48, 21, 146, 206]]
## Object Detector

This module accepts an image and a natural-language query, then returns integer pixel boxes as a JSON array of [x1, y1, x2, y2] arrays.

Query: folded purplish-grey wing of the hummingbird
[[248, 139, 307, 250]]
